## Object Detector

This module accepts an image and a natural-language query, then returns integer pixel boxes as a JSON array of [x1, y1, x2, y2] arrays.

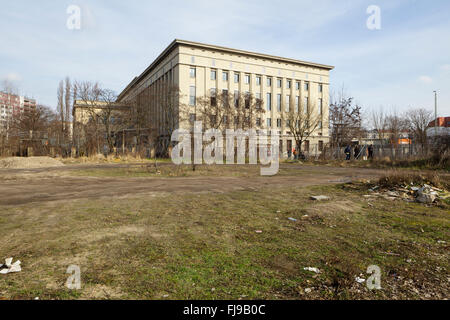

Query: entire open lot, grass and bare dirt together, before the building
[[0, 163, 450, 300]]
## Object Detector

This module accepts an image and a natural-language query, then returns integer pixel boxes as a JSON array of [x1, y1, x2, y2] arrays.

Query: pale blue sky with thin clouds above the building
[[0, 0, 450, 116]]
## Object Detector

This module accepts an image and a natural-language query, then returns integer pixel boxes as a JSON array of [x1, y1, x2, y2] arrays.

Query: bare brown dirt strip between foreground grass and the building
[[0, 164, 386, 205]]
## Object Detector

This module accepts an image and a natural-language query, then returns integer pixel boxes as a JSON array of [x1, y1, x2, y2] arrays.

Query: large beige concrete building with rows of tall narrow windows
[[118, 39, 334, 156]]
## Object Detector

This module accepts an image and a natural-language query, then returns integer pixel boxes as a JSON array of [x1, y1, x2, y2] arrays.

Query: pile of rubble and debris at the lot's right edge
[[363, 184, 450, 204]]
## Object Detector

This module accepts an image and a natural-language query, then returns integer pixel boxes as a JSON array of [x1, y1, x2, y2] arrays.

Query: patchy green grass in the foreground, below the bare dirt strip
[[0, 185, 450, 299]]
